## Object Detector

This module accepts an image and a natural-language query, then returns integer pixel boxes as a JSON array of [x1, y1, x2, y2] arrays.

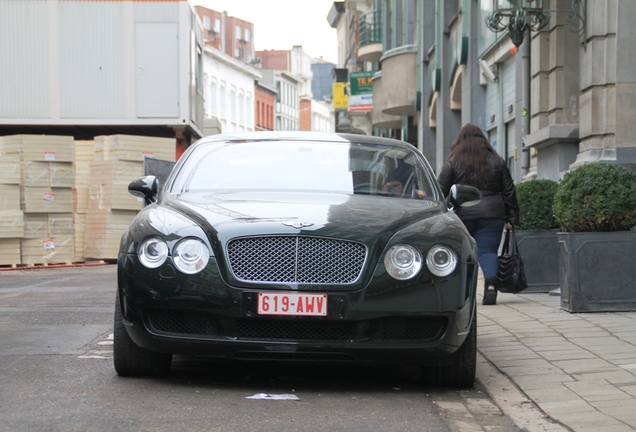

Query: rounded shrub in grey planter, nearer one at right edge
[[553, 162, 636, 312]]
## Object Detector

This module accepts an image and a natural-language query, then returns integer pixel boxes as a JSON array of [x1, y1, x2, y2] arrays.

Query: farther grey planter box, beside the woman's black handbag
[[515, 229, 559, 294]]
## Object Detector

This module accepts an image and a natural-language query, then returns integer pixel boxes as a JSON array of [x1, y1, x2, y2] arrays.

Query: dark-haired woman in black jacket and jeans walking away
[[439, 123, 519, 305]]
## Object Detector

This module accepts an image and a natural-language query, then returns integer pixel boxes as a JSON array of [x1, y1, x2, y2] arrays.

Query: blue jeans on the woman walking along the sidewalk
[[463, 219, 506, 283]]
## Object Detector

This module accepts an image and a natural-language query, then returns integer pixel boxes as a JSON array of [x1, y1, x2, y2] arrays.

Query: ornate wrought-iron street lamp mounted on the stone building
[[486, 0, 587, 48]]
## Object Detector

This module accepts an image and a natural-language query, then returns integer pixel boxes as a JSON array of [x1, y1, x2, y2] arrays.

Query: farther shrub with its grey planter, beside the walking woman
[[515, 179, 559, 293]]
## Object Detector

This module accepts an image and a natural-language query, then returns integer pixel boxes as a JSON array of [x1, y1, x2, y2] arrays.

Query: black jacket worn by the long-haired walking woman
[[439, 154, 519, 225]]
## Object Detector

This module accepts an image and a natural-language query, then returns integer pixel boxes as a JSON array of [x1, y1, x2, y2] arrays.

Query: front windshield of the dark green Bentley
[[170, 141, 435, 199]]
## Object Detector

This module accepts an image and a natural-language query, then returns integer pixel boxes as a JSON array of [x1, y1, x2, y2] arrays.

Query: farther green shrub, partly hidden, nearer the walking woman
[[516, 179, 559, 230]]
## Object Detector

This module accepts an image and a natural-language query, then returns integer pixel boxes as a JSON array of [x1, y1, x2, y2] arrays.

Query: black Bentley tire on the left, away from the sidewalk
[[113, 293, 172, 376]]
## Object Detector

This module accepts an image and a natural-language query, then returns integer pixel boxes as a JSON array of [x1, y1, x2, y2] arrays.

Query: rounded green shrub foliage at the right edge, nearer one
[[553, 162, 636, 232]]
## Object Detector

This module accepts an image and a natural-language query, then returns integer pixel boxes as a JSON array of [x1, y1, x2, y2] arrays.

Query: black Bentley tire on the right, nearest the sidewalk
[[422, 311, 477, 388]]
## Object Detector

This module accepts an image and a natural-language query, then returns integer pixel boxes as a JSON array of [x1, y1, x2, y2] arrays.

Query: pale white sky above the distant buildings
[[190, 0, 338, 64]]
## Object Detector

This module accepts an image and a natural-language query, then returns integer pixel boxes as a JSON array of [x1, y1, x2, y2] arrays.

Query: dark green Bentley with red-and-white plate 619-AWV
[[114, 132, 479, 387]]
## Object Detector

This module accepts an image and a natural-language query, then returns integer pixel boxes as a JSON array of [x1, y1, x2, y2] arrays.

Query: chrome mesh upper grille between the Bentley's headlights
[[228, 236, 366, 284]]
